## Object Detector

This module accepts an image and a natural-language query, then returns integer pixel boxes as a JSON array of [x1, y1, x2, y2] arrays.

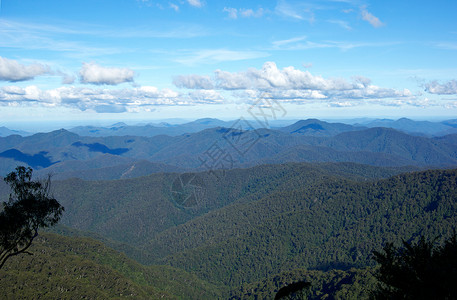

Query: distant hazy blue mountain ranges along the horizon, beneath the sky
[[0, 119, 457, 179]]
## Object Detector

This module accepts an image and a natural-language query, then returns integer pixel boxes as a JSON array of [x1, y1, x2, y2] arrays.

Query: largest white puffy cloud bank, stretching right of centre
[[174, 62, 414, 103]]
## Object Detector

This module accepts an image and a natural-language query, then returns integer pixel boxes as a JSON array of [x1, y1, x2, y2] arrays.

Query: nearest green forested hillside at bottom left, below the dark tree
[[0, 233, 221, 299]]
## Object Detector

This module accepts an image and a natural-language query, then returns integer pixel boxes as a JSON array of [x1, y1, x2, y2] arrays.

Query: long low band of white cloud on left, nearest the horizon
[[0, 86, 223, 113]]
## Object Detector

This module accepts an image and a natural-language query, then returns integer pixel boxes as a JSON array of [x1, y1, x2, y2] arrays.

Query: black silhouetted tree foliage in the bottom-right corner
[[373, 232, 457, 299]]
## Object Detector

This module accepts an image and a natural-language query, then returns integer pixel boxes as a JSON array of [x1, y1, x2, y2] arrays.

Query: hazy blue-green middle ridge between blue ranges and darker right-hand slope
[[41, 163, 410, 251]]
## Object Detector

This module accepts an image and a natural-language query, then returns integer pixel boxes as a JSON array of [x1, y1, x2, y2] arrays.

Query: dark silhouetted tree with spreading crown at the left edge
[[0, 166, 64, 269]]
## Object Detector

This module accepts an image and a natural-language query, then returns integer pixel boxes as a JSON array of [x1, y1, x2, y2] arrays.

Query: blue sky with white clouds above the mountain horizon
[[0, 0, 457, 126]]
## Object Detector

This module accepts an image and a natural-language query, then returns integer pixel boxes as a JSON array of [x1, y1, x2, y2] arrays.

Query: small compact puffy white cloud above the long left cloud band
[[79, 63, 135, 85]]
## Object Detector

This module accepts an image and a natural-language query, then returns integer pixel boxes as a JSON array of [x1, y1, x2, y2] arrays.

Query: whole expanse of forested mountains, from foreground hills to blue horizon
[[0, 115, 457, 299]]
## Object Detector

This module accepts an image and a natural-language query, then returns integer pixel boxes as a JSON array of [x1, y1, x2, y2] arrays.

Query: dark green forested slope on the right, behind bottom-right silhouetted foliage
[[145, 170, 457, 286]]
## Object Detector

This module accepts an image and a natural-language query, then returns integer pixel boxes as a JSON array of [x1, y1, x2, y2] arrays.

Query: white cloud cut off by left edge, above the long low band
[[0, 56, 50, 82]]
